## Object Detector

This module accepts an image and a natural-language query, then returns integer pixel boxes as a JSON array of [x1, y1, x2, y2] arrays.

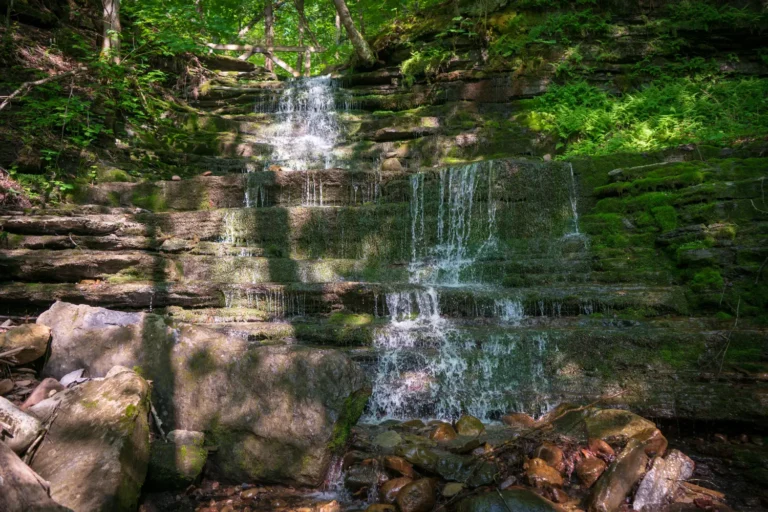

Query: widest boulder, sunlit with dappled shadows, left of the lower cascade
[[38, 302, 369, 485]]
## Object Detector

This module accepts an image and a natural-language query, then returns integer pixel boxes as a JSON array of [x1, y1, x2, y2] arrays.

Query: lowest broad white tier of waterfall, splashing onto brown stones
[[364, 288, 551, 421]]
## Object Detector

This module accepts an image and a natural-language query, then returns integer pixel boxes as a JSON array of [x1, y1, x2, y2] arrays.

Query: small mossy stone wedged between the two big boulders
[[145, 430, 208, 490]]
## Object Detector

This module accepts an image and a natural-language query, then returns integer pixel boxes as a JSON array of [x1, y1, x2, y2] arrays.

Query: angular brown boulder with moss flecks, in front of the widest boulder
[[29, 367, 149, 512]]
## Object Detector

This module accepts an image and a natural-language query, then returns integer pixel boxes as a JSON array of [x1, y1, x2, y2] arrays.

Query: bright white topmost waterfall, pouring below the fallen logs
[[255, 76, 341, 170]]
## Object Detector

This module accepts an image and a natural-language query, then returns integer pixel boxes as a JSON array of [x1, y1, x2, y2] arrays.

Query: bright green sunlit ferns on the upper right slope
[[532, 78, 768, 155]]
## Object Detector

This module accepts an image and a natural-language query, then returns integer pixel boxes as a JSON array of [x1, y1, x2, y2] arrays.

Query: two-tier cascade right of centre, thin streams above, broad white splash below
[[366, 162, 581, 421]]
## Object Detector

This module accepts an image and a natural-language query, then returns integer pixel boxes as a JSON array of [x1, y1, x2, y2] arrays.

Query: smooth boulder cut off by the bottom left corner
[[0, 443, 71, 512]]
